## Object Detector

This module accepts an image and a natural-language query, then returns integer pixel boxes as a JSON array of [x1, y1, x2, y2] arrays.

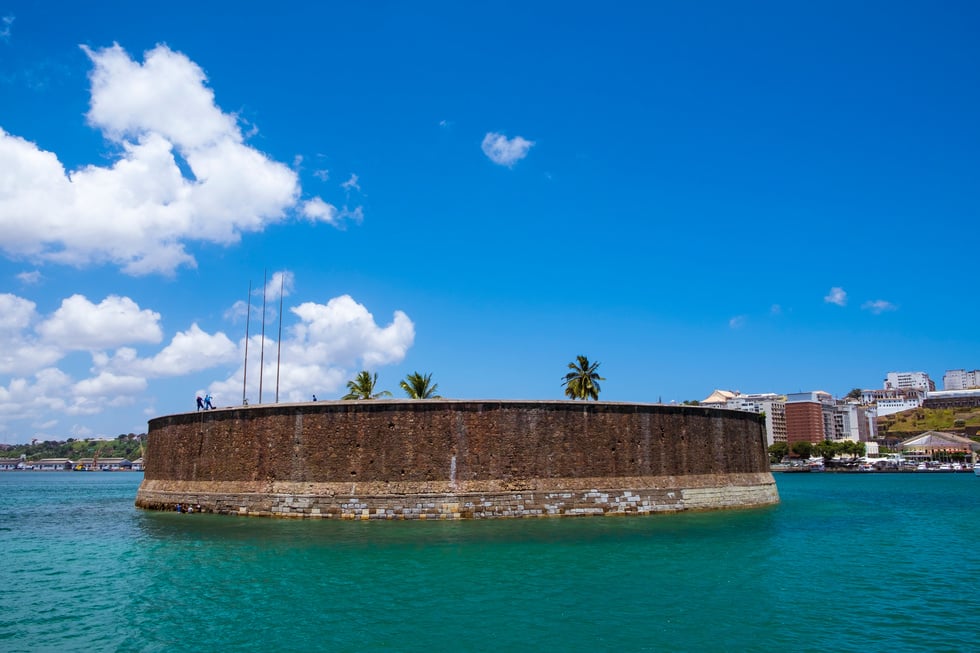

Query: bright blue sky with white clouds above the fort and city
[[0, 2, 980, 443]]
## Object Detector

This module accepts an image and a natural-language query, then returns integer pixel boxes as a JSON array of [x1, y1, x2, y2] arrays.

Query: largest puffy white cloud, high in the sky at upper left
[[0, 45, 352, 275]]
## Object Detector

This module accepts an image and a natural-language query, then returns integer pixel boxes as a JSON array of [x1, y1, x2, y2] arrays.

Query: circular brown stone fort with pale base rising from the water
[[136, 399, 779, 519]]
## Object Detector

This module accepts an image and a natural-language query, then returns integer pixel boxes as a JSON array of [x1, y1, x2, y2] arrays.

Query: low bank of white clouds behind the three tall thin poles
[[0, 288, 415, 435]]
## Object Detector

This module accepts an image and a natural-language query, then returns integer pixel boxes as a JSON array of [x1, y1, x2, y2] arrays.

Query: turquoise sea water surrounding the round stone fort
[[0, 472, 980, 653]]
